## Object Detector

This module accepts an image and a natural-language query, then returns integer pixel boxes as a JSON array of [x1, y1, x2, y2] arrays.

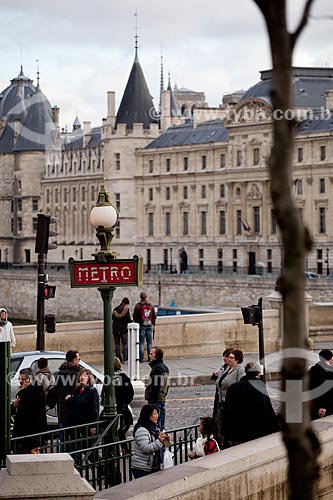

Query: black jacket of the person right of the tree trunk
[[309, 361, 333, 420]]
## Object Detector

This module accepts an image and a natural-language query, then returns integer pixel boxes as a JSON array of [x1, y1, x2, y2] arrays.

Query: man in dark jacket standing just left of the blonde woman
[[55, 350, 81, 427]]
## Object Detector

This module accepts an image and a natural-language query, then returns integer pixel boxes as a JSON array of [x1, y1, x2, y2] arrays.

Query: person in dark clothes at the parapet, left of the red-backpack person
[[112, 297, 132, 363]]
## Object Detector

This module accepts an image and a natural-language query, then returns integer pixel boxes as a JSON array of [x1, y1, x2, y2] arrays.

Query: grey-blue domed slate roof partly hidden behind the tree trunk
[[241, 67, 333, 109]]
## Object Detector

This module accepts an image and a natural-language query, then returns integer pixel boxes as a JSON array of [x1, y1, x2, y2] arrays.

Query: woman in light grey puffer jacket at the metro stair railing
[[132, 404, 170, 479]]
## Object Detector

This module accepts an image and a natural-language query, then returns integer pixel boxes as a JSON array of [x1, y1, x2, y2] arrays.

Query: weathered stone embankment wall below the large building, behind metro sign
[[0, 269, 333, 322]]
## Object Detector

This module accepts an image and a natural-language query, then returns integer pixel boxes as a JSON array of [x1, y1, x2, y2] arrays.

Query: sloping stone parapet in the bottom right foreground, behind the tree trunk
[[95, 417, 333, 500]]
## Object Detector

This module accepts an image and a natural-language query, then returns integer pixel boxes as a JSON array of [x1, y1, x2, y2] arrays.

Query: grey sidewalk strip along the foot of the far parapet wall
[[96, 341, 333, 386]]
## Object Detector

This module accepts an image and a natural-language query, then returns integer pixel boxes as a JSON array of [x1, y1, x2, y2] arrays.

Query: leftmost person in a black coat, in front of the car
[[12, 368, 47, 437]]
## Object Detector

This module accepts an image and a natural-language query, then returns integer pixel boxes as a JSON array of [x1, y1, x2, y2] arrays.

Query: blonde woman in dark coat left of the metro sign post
[[65, 368, 99, 435]]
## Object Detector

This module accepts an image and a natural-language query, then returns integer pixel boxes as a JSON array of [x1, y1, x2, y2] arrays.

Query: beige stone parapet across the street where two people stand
[[13, 310, 279, 363]]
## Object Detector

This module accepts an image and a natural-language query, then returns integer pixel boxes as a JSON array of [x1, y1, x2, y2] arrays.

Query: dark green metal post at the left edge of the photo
[[0, 342, 10, 463]]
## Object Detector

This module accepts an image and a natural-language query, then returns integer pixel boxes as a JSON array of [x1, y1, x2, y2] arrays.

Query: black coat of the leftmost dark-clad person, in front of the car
[[13, 384, 47, 437]]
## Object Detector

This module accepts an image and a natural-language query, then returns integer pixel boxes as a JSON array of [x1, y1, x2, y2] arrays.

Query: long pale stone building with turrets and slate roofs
[[0, 56, 333, 274]]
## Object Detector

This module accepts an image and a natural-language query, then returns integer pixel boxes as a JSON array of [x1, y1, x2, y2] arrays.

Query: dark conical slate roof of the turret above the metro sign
[[116, 47, 158, 129]]
